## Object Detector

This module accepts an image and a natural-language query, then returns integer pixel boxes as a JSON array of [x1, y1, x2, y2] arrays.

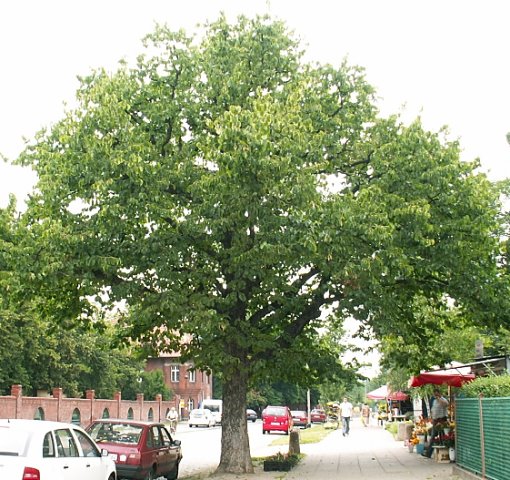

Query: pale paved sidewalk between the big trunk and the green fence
[[190, 419, 459, 480]]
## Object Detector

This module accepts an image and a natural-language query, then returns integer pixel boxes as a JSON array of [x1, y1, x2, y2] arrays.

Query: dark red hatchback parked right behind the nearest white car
[[86, 418, 182, 480]]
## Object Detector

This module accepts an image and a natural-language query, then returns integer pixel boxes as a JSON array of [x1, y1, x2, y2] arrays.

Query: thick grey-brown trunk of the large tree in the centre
[[216, 369, 253, 474]]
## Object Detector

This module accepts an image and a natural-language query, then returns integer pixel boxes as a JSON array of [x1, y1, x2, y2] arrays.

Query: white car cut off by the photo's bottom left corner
[[0, 419, 117, 480]]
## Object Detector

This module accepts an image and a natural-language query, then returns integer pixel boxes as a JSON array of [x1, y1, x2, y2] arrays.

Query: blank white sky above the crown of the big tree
[[0, 0, 510, 206]]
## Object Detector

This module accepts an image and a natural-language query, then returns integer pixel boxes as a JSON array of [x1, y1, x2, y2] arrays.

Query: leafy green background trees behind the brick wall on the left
[[0, 206, 151, 400]]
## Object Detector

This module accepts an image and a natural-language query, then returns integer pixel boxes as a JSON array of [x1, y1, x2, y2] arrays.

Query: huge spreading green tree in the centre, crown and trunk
[[13, 18, 499, 473]]
